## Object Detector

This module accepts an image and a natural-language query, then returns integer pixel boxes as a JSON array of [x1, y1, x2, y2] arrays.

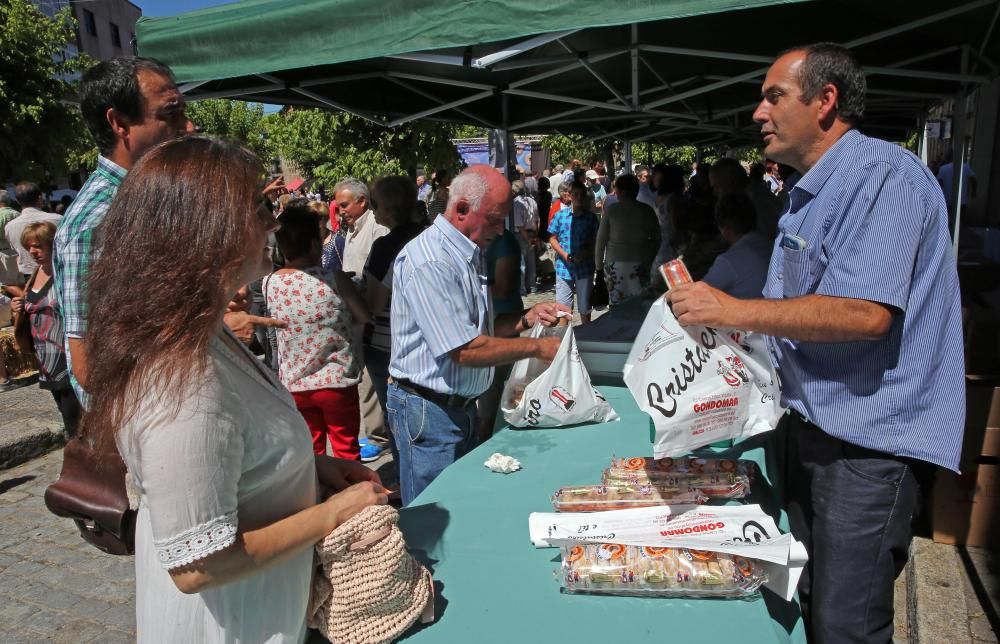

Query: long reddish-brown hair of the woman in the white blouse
[[82, 136, 274, 447]]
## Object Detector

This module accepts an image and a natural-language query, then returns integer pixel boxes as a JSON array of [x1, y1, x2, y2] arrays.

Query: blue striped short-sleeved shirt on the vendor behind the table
[[764, 130, 965, 471]]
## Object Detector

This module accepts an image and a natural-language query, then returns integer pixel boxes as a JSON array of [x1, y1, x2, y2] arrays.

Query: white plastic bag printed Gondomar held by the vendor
[[624, 298, 784, 458]]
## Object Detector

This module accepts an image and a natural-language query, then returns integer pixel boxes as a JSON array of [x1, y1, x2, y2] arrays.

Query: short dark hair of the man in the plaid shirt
[[80, 56, 174, 155]]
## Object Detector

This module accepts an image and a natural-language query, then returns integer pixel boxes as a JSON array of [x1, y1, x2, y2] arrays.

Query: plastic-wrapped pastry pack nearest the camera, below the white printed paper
[[562, 543, 767, 598]]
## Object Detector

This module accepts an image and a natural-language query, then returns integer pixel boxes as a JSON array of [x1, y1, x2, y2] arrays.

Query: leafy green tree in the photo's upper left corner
[[0, 0, 96, 180]]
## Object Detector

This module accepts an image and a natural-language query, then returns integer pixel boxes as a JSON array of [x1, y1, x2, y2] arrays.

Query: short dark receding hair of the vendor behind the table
[[781, 42, 868, 125]]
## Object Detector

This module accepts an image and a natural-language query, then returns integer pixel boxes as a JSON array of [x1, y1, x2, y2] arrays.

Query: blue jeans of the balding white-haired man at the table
[[386, 383, 476, 505]]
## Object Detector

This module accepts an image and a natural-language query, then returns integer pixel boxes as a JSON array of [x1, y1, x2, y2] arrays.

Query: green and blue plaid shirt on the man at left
[[52, 156, 125, 400]]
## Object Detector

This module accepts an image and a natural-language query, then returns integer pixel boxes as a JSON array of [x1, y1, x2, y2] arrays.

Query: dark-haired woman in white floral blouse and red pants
[[264, 207, 368, 460]]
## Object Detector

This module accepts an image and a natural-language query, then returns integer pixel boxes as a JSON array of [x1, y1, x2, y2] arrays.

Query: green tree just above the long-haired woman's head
[[187, 99, 276, 165]]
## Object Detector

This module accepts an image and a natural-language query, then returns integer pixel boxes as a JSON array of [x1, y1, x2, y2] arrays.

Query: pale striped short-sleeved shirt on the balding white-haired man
[[389, 217, 493, 397]]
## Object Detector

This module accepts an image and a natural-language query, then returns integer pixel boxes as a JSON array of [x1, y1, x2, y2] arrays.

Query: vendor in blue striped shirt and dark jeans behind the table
[[670, 44, 965, 642]]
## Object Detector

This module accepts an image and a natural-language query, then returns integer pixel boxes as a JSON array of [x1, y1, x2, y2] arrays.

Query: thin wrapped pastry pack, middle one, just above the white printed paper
[[552, 483, 708, 512]]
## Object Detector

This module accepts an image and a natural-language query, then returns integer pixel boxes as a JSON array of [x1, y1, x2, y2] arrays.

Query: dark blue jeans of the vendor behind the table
[[782, 414, 934, 644]]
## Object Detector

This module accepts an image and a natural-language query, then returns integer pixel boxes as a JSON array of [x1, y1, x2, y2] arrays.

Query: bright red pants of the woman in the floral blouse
[[292, 385, 361, 461]]
